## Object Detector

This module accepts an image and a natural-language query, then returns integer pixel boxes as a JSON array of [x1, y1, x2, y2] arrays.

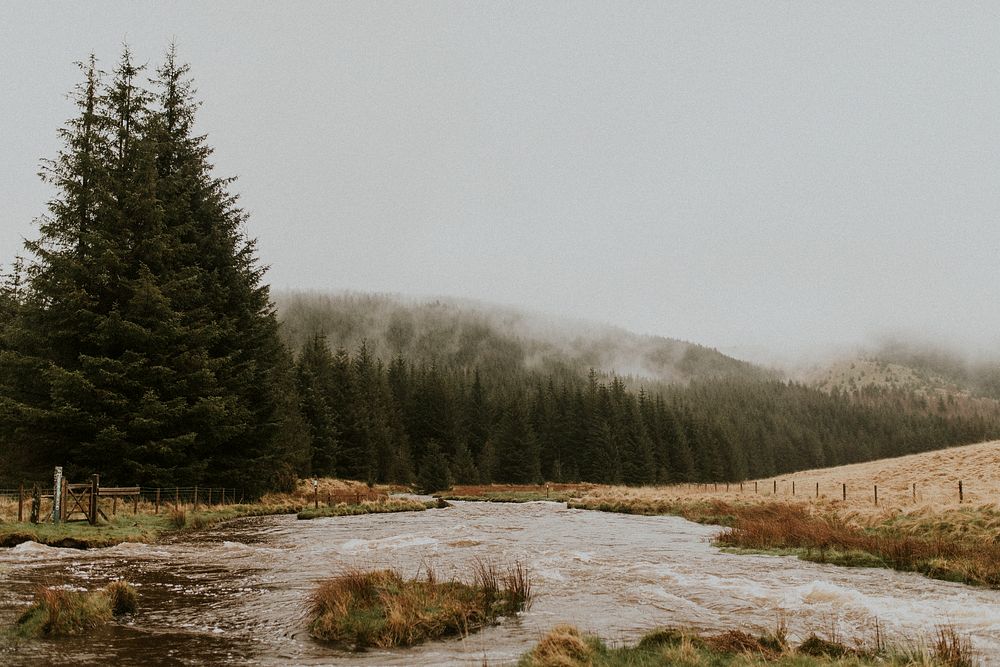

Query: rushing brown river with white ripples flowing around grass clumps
[[0, 503, 1000, 665]]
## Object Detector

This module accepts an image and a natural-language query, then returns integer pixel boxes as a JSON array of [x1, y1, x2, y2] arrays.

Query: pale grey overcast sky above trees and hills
[[0, 0, 1000, 362]]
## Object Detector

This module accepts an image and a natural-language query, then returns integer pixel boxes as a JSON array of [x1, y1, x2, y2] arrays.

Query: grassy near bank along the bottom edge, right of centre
[[518, 625, 975, 667]]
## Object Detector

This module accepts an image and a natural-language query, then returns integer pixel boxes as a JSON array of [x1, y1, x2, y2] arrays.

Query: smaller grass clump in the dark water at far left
[[15, 581, 139, 637]]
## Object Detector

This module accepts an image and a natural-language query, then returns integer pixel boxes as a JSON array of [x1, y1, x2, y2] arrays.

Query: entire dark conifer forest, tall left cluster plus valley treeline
[[0, 49, 1000, 495]]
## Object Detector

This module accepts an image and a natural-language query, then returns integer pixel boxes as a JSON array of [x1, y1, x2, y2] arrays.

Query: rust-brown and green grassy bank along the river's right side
[[569, 498, 1000, 588]]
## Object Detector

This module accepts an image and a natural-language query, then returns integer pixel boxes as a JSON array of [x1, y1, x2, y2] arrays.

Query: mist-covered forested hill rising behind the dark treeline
[[274, 292, 773, 387]]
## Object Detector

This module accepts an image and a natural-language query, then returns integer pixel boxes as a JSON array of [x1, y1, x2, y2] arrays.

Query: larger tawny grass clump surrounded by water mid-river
[[309, 561, 531, 650]]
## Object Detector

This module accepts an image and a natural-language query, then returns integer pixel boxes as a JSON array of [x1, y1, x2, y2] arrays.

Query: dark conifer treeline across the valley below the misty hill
[[296, 335, 1000, 489]]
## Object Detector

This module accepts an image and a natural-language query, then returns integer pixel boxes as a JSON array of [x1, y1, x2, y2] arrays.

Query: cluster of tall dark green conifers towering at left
[[0, 49, 309, 495]]
